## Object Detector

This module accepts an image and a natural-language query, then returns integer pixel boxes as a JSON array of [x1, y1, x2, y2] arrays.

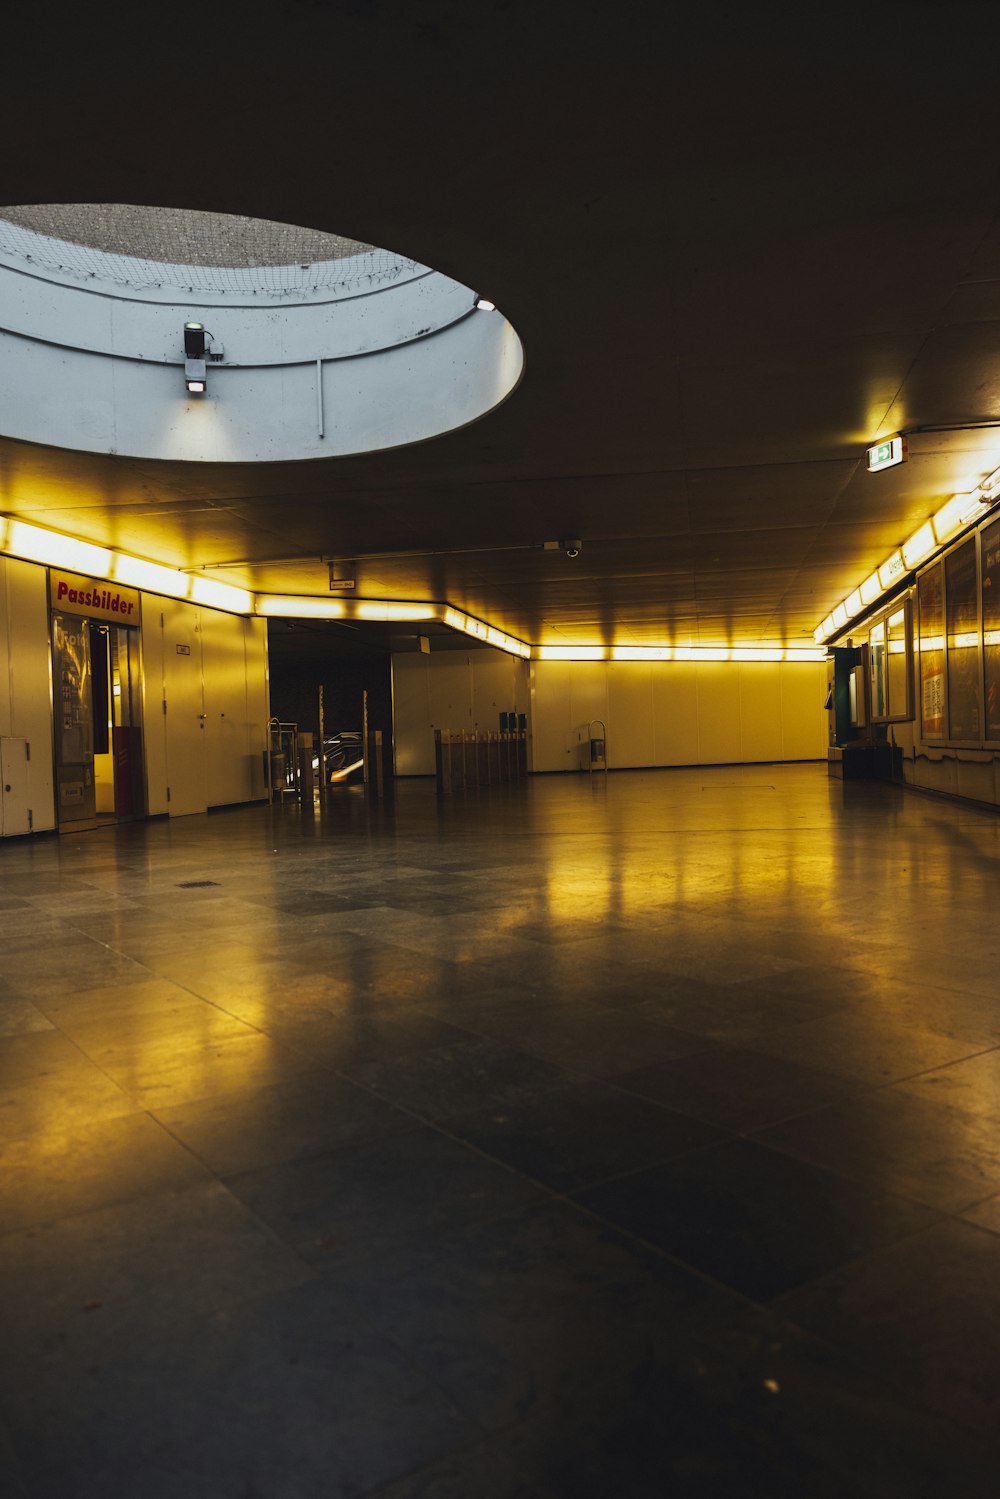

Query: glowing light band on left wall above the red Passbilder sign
[[0, 517, 253, 615]]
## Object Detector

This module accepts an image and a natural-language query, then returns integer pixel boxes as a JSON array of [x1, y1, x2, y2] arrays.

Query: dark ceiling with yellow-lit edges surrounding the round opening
[[0, 0, 1000, 643]]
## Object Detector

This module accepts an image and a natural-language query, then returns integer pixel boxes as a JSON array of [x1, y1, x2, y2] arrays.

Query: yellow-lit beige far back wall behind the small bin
[[529, 661, 826, 770]]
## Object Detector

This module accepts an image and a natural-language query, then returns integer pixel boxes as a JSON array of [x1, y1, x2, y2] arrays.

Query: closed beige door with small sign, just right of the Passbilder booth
[[162, 600, 208, 817]]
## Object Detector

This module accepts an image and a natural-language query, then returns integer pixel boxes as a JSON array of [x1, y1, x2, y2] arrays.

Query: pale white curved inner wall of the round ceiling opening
[[0, 205, 523, 463]]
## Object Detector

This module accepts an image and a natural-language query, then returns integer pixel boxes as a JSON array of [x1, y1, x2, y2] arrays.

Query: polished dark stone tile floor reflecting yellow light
[[0, 766, 1000, 1499]]
